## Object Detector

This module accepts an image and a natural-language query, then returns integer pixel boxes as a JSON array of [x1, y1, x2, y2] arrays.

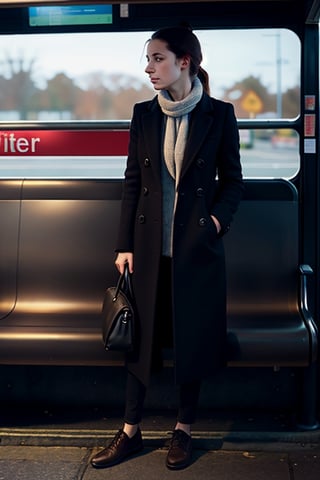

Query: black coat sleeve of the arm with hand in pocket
[[210, 103, 244, 236]]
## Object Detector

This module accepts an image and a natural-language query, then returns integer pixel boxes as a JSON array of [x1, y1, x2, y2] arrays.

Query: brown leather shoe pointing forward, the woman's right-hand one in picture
[[166, 429, 192, 470]]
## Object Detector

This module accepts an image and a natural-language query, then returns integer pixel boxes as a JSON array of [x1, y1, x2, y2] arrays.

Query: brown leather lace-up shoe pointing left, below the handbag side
[[91, 429, 143, 468]]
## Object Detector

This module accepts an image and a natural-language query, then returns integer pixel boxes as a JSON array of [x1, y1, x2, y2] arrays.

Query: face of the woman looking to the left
[[145, 39, 190, 93]]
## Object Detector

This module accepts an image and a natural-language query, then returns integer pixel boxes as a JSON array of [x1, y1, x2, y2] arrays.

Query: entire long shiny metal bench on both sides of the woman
[[0, 180, 318, 429]]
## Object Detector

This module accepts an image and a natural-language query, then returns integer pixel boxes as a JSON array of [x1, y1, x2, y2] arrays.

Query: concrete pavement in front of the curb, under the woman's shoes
[[0, 446, 320, 480]]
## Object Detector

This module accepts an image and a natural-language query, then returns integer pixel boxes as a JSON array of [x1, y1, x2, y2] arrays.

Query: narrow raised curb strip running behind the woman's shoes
[[0, 428, 320, 451]]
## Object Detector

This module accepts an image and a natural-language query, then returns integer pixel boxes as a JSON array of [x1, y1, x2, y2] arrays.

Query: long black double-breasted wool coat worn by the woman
[[117, 93, 243, 384]]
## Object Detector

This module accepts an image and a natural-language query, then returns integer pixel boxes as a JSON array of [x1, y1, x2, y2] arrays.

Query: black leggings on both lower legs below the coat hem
[[124, 372, 201, 425]]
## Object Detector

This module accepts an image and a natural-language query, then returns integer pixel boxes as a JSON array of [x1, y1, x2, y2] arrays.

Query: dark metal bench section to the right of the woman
[[225, 180, 317, 367]]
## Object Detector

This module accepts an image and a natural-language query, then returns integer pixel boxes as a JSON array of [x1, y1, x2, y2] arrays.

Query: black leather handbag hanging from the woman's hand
[[102, 264, 135, 352]]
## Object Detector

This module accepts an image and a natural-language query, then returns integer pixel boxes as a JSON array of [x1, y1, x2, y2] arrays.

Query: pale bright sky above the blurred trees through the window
[[0, 29, 300, 96]]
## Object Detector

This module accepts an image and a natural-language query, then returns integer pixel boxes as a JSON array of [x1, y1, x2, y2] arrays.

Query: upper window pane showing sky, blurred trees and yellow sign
[[0, 29, 300, 120]]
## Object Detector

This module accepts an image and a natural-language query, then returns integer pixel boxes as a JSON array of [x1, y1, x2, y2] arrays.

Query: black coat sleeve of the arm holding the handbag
[[116, 105, 141, 252]]
